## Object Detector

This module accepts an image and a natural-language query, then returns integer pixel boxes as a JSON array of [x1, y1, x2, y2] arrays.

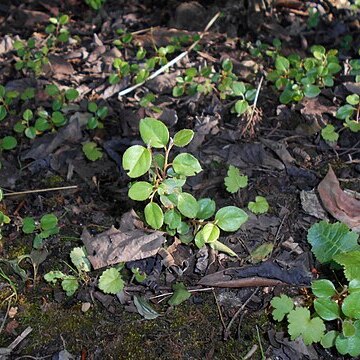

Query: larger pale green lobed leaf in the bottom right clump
[[288, 307, 325, 345]]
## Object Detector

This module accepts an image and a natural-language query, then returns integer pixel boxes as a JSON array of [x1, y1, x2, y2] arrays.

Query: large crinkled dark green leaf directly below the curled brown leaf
[[307, 221, 360, 263]]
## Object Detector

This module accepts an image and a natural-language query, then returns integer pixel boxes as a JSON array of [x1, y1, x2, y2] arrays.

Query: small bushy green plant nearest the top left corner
[[14, 38, 49, 76]]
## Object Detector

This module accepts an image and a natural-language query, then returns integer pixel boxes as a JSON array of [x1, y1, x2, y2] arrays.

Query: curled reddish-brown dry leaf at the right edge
[[318, 166, 360, 232]]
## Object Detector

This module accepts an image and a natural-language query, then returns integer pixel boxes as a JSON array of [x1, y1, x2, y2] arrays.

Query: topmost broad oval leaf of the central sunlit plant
[[139, 117, 169, 148]]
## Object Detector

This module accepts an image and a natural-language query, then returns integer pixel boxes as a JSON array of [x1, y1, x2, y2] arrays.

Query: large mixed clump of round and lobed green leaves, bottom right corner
[[271, 221, 360, 357]]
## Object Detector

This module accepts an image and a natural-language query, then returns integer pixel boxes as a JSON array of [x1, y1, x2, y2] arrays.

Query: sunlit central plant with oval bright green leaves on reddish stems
[[122, 118, 248, 255]]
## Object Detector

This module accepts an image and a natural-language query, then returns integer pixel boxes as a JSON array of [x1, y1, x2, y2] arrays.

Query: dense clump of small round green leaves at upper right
[[267, 45, 341, 104]]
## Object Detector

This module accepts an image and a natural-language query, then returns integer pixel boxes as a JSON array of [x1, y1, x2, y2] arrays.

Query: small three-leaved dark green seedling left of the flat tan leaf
[[22, 214, 60, 249]]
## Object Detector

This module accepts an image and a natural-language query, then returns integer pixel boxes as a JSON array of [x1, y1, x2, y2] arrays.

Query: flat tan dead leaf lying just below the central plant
[[81, 210, 165, 269]]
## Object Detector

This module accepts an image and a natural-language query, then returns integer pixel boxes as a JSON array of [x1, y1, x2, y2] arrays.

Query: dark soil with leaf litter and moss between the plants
[[0, 0, 360, 359]]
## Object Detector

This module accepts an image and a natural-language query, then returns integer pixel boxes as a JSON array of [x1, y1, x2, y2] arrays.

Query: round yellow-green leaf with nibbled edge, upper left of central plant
[[122, 145, 151, 178]]
